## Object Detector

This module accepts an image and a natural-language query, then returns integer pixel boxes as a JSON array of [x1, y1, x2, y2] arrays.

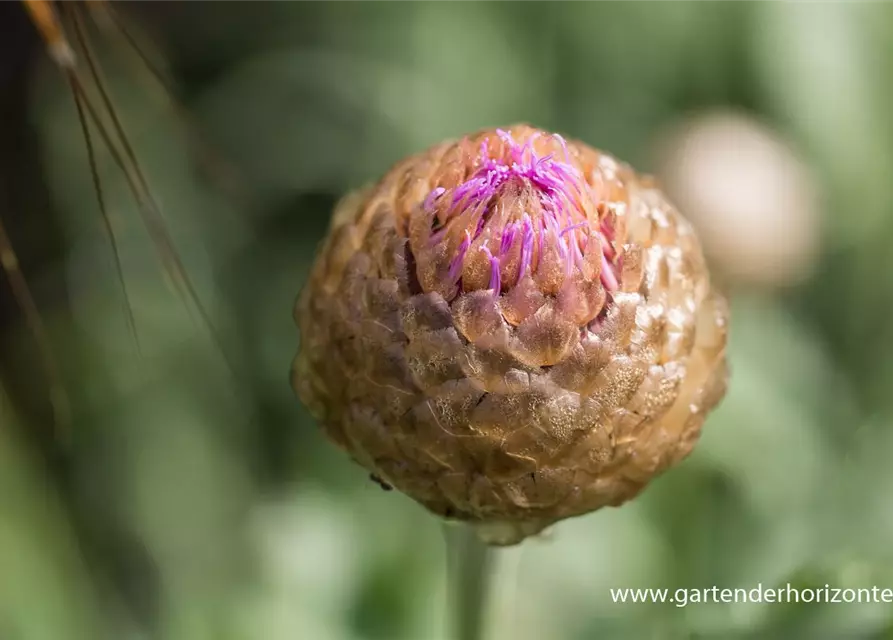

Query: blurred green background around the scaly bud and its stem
[[0, 0, 893, 640]]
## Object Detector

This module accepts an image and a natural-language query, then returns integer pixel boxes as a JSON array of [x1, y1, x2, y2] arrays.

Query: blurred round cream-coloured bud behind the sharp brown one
[[656, 112, 821, 287]]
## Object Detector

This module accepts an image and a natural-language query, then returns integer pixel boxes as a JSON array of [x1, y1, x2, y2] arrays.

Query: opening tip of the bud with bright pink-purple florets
[[422, 129, 617, 297]]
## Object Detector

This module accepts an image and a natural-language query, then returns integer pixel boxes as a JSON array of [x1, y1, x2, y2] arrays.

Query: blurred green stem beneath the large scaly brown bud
[[444, 523, 496, 640]]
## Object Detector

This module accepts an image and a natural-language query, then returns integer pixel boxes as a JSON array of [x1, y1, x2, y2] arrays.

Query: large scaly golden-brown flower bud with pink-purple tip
[[292, 126, 728, 544]]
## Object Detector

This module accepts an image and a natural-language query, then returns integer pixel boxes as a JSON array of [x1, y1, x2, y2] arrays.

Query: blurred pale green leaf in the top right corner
[[751, 0, 893, 244]]
